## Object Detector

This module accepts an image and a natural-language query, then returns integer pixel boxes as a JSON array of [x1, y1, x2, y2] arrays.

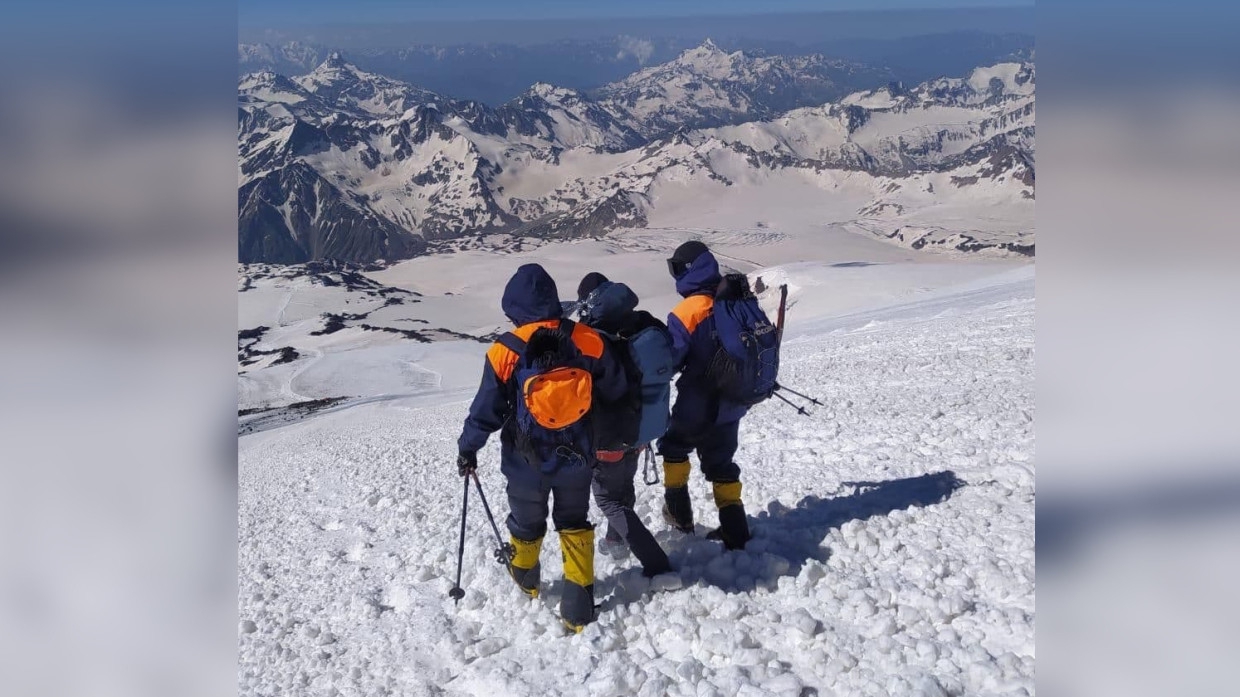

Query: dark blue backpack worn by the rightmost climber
[[707, 274, 779, 406]]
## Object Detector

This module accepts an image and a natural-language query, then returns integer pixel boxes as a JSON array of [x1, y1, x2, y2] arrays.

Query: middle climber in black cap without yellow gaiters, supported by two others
[[577, 272, 672, 577]]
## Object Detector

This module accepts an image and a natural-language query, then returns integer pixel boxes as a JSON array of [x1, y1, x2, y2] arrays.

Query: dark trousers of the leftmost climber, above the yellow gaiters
[[500, 445, 593, 542]]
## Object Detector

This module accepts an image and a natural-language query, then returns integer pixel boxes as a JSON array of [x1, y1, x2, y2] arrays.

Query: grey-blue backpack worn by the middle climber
[[582, 283, 676, 448]]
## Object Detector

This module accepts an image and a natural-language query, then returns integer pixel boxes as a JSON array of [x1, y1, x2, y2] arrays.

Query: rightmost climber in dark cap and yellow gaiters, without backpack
[[658, 241, 749, 549]]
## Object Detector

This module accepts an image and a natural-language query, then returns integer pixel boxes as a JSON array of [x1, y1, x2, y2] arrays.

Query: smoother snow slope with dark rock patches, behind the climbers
[[238, 225, 1024, 414]]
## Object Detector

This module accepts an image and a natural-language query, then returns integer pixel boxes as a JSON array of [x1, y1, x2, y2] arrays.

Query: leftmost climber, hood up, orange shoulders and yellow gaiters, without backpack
[[458, 264, 626, 631]]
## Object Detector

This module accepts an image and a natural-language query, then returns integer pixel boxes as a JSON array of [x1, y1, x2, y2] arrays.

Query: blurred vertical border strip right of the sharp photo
[[1037, 0, 1240, 696]]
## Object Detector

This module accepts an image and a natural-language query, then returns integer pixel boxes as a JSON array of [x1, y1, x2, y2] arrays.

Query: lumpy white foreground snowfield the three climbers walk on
[[238, 264, 1035, 697]]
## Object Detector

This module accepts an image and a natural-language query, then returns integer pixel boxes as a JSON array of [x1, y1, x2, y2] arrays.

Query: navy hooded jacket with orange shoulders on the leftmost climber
[[456, 264, 625, 453]]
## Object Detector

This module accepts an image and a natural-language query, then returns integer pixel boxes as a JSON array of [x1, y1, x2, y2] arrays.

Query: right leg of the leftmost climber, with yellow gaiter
[[551, 465, 594, 631]]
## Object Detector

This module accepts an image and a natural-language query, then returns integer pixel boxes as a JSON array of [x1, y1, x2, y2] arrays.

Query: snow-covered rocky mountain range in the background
[[241, 54, 1034, 254]]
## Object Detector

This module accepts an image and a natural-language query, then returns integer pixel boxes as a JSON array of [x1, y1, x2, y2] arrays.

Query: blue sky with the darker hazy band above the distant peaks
[[238, 0, 1034, 50]]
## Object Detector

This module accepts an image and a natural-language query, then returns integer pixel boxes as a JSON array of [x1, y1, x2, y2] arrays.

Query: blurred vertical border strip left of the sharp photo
[[0, 0, 237, 696]]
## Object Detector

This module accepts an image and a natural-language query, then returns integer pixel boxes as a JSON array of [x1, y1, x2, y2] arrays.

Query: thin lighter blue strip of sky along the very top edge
[[238, 0, 1033, 27]]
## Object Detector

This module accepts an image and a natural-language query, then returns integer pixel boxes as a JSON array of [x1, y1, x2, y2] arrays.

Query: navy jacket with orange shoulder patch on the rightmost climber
[[667, 252, 749, 424]]
